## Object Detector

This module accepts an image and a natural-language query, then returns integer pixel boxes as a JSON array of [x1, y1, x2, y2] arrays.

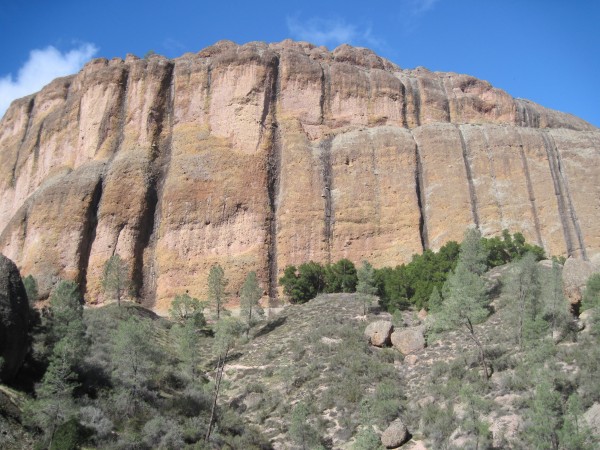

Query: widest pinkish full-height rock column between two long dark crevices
[[155, 45, 278, 312]]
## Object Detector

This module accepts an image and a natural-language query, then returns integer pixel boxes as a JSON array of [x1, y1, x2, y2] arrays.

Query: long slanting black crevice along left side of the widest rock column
[[137, 63, 174, 307]]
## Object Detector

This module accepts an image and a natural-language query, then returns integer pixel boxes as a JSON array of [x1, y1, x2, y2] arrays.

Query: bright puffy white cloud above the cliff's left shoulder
[[0, 43, 98, 117]]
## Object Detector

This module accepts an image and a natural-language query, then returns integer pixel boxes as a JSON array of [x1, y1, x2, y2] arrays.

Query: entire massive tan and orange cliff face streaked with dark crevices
[[0, 41, 600, 312]]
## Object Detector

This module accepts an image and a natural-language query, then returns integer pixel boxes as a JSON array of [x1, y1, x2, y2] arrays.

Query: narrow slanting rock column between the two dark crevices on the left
[[86, 57, 173, 302]]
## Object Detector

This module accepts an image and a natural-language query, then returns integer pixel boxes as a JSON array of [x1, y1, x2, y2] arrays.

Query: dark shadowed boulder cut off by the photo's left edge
[[0, 254, 29, 382]]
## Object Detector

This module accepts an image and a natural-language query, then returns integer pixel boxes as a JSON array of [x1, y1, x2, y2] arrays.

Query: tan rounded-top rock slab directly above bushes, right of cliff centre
[[331, 127, 423, 266]]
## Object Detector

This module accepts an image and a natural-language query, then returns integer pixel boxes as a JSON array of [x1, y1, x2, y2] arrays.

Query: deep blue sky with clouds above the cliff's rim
[[0, 0, 600, 127]]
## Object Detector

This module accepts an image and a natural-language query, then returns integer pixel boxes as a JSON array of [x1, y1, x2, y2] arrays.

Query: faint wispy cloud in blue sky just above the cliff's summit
[[287, 16, 385, 48]]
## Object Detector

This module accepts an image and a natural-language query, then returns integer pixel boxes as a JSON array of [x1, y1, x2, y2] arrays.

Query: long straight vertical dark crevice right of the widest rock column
[[265, 53, 281, 306]]
